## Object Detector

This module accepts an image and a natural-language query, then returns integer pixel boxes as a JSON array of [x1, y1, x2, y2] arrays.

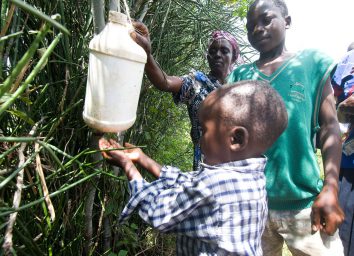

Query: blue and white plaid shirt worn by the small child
[[121, 158, 268, 256]]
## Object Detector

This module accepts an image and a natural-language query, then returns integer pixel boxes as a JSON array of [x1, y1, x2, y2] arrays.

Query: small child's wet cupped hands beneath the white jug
[[98, 138, 142, 180]]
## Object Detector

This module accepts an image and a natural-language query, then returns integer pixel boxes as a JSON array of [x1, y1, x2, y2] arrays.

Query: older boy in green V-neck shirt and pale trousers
[[229, 0, 343, 256]]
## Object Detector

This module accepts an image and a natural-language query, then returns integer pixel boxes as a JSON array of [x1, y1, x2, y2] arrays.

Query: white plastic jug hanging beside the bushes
[[83, 11, 147, 132]]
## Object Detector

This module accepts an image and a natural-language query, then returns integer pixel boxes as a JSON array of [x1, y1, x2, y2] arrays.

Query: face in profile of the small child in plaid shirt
[[199, 93, 229, 165]]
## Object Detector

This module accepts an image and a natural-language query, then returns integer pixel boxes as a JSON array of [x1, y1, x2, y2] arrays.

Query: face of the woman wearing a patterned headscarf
[[208, 39, 235, 80]]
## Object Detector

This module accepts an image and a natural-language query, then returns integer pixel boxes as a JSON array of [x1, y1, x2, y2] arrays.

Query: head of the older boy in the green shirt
[[246, 0, 291, 53]]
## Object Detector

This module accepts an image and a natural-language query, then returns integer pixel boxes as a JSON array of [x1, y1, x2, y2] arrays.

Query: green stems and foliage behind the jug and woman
[[0, 0, 254, 255]]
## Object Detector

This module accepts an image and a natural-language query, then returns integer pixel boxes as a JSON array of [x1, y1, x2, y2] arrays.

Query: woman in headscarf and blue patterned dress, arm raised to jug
[[132, 22, 240, 170]]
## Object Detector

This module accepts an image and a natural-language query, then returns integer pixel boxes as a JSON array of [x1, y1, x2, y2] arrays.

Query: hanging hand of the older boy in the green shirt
[[311, 185, 344, 235]]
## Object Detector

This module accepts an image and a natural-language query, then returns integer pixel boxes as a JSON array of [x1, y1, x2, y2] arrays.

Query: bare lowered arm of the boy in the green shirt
[[312, 79, 344, 235]]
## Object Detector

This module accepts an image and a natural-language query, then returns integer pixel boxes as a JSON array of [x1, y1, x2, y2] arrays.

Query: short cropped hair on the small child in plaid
[[216, 80, 288, 149]]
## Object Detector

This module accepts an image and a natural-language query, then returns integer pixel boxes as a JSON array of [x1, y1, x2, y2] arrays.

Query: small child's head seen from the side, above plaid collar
[[199, 80, 288, 165]]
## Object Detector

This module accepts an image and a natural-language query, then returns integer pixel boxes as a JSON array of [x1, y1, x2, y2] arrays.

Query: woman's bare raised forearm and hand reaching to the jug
[[131, 21, 183, 93]]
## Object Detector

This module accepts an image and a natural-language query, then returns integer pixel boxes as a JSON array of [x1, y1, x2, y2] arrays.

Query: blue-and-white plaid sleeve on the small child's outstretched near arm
[[121, 166, 216, 233]]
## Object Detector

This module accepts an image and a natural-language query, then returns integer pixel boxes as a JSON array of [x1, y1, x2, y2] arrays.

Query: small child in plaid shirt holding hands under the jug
[[100, 81, 287, 255]]
